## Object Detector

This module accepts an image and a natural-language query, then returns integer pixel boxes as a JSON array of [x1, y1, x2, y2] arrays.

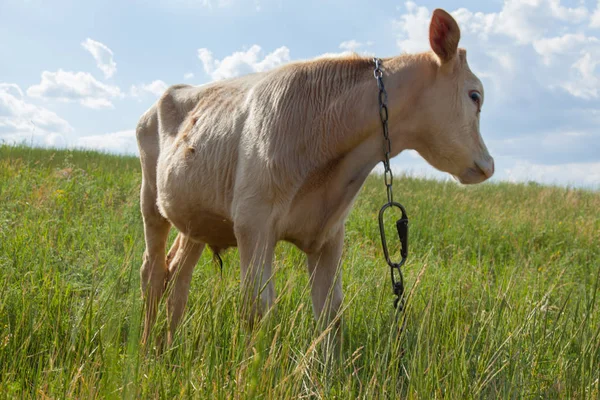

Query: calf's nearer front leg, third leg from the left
[[235, 220, 276, 327]]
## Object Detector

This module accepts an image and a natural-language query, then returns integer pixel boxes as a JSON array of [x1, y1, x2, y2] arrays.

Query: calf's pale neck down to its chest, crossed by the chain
[[300, 56, 431, 242]]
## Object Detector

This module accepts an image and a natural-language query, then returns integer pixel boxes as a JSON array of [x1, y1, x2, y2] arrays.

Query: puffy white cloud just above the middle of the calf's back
[[198, 44, 290, 81]]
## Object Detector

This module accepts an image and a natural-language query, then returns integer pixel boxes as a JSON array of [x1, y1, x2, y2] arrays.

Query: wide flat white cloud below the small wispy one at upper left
[[27, 69, 124, 109]]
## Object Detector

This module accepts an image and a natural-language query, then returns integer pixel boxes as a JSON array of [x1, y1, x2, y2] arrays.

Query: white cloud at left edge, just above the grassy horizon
[[0, 83, 74, 145]]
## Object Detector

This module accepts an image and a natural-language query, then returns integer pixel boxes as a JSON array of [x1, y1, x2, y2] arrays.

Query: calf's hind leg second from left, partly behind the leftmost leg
[[167, 233, 205, 346]]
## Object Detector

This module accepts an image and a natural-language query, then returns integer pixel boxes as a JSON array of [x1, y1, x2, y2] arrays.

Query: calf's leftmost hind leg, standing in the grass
[[140, 181, 171, 344]]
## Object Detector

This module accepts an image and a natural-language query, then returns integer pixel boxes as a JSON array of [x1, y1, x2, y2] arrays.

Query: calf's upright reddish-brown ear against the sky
[[429, 8, 460, 64]]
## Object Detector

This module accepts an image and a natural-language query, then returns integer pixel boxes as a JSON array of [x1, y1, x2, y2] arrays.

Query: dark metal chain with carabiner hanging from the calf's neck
[[373, 58, 408, 311]]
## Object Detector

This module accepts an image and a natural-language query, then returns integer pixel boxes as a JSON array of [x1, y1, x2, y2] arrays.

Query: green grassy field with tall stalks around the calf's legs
[[0, 146, 600, 399]]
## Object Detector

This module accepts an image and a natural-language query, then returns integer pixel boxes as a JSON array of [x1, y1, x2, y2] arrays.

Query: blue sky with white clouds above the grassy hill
[[0, 0, 600, 188]]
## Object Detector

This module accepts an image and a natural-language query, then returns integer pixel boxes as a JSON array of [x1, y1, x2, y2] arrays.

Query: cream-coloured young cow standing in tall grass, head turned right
[[137, 10, 494, 343]]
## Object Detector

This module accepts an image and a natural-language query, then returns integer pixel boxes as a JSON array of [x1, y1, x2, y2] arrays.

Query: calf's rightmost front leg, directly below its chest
[[307, 227, 344, 344]]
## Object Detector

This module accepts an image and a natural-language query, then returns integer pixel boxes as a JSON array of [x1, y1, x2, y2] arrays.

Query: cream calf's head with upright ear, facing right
[[415, 9, 494, 184]]
